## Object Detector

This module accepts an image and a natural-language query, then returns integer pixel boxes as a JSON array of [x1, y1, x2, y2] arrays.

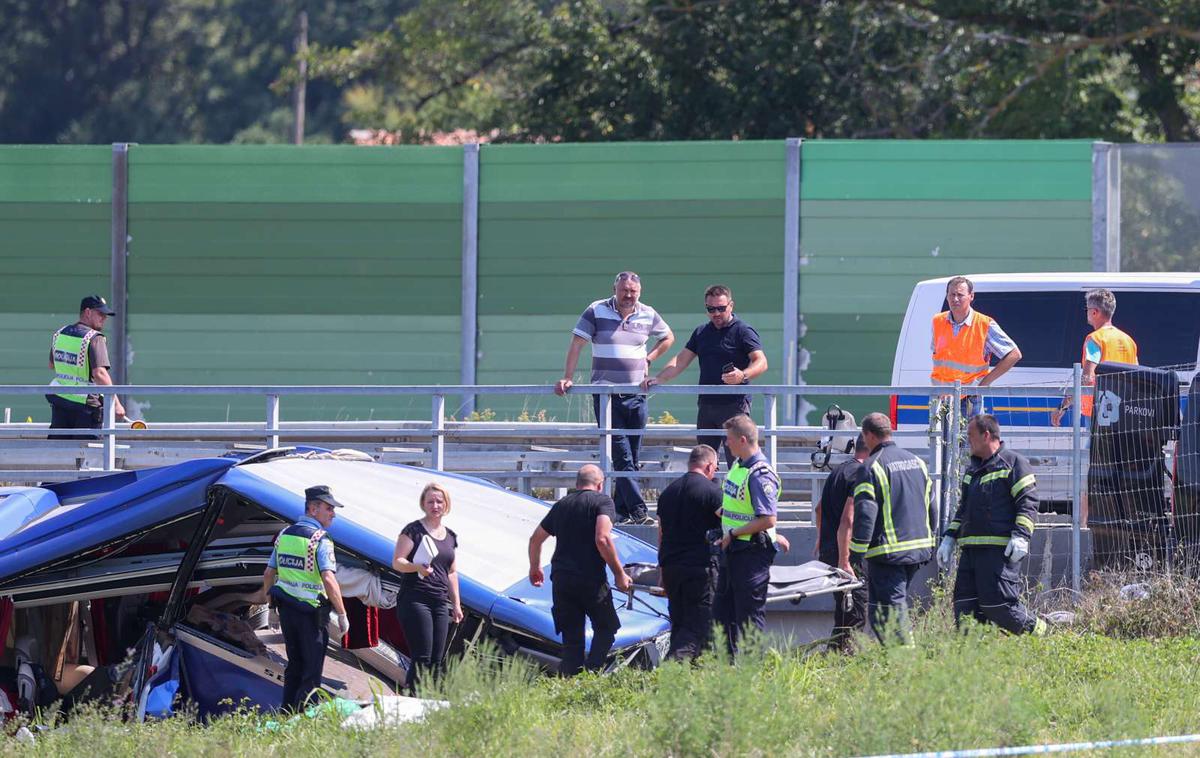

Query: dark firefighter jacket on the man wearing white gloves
[[946, 444, 1038, 547]]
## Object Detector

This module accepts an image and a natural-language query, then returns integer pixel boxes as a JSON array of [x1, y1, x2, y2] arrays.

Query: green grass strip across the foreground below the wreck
[[9, 597, 1200, 758]]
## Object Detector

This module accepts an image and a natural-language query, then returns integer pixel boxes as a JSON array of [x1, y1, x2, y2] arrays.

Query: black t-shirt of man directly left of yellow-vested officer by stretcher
[[658, 471, 721, 567]]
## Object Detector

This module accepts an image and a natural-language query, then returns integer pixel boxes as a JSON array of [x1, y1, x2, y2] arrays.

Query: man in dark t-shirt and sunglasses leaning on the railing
[[642, 284, 767, 468]]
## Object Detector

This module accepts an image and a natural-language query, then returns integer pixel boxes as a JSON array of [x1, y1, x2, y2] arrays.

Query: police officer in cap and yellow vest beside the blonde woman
[[259, 485, 350, 710]]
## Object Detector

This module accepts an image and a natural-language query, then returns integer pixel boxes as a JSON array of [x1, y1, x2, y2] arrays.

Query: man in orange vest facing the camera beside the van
[[930, 276, 1021, 410]]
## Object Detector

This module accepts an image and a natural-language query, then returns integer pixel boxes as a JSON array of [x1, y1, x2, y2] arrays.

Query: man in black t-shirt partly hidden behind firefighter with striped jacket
[[812, 434, 870, 652]]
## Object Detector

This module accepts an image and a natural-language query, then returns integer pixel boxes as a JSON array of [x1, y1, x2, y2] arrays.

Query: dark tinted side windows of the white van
[[964, 290, 1200, 368]]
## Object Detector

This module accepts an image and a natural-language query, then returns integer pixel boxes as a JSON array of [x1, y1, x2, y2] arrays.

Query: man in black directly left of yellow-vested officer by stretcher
[[658, 445, 721, 660]]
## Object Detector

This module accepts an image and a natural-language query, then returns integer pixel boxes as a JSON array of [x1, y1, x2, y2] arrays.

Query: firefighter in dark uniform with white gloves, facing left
[[937, 415, 1046, 634]]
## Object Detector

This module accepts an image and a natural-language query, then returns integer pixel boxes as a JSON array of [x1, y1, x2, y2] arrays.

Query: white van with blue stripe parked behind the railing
[[890, 272, 1200, 499]]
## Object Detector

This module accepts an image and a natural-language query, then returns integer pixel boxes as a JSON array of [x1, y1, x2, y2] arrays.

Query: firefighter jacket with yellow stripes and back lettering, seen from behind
[[850, 441, 934, 565]]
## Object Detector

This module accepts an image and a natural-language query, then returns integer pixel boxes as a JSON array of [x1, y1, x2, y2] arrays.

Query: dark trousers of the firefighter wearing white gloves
[[954, 546, 1038, 634]]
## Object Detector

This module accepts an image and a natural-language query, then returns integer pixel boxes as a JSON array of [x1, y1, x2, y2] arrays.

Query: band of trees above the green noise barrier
[[7, 0, 1200, 143]]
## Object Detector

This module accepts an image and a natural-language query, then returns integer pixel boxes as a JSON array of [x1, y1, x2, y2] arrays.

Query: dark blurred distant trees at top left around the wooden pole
[[0, 0, 413, 143]]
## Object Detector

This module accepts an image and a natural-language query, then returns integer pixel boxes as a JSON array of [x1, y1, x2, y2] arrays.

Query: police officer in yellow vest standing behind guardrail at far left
[[46, 295, 125, 439]]
